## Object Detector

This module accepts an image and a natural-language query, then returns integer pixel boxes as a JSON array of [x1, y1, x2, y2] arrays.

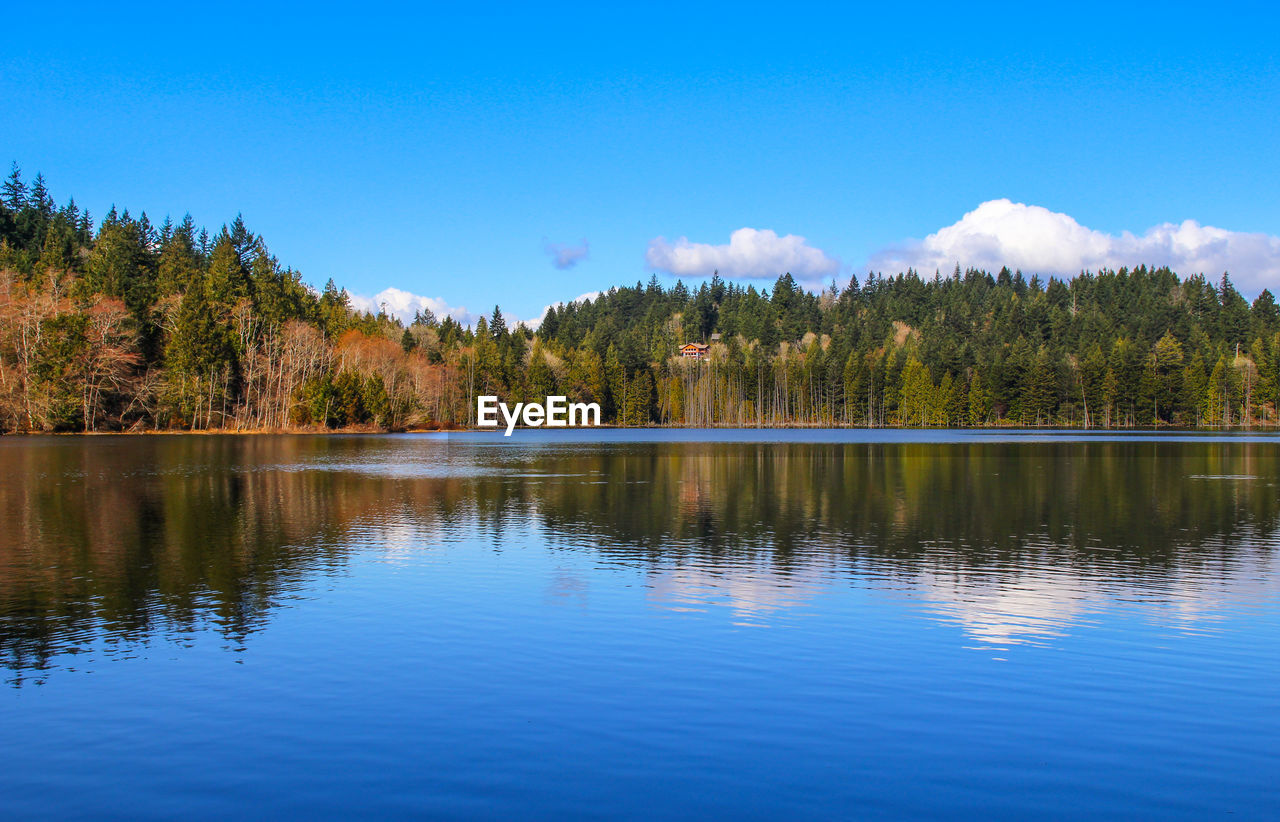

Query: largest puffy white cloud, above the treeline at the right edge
[[868, 200, 1280, 294]]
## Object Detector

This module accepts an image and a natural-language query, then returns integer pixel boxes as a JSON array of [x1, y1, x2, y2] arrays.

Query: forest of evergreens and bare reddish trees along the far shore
[[0, 164, 1280, 433]]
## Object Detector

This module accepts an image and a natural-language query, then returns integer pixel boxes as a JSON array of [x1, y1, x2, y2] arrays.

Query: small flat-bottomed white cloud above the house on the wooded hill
[[644, 228, 840, 282]]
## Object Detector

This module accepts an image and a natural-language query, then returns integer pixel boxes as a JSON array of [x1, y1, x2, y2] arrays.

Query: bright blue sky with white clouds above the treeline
[[0, 4, 1280, 318]]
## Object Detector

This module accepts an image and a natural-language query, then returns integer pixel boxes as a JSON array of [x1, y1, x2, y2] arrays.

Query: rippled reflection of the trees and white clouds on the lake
[[0, 437, 1280, 681]]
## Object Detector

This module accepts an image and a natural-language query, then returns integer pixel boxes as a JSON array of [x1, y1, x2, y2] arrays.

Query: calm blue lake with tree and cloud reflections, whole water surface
[[0, 430, 1280, 819]]
